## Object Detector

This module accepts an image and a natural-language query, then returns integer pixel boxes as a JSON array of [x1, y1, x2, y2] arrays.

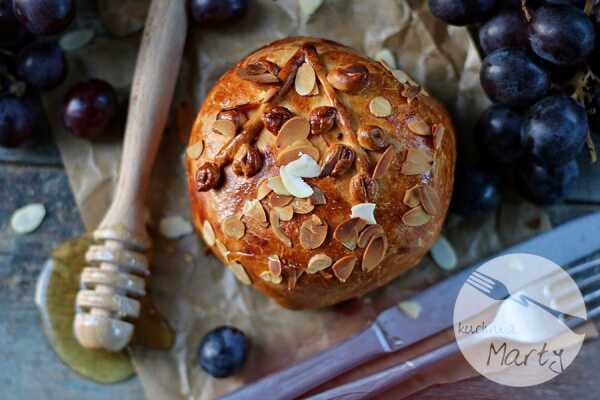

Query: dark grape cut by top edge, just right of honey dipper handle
[[189, 0, 248, 25]]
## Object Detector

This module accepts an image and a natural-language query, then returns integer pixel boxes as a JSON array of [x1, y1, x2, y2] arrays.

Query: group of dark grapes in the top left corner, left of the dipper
[[0, 0, 117, 147]]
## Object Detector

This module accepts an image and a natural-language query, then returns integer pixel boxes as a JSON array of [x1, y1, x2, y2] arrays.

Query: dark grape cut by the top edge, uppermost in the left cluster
[[13, 0, 75, 35]]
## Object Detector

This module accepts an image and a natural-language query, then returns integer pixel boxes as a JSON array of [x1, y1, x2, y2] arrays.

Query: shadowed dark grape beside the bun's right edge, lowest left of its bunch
[[452, 166, 502, 217]]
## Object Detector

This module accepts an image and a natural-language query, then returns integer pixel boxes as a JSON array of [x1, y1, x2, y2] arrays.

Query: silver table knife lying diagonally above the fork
[[220, 212, 600, 400]]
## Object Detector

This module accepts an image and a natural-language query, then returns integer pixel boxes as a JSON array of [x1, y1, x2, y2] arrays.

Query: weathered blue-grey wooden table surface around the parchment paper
[[0, 135, 600, 400]]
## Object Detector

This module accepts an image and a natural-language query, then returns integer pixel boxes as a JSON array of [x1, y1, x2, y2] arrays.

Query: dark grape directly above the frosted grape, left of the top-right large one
[[479, 10, 529, 54]]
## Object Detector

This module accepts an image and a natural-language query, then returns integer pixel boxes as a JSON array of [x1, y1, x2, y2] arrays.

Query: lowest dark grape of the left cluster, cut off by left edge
[[0, 95, 39, 147]]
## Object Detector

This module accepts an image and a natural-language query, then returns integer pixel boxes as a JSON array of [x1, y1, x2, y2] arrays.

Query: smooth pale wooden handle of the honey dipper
[[100, 0, 187, 236]]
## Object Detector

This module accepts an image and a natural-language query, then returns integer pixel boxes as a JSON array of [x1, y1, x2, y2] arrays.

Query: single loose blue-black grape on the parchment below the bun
[[198, 326, 250, 378]]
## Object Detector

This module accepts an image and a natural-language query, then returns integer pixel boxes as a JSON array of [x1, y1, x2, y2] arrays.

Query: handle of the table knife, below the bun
[[220, 324, 387, 400]]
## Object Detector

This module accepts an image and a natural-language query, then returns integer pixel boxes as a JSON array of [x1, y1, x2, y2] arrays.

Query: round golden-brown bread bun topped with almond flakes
[[186, 37, 456, 309]]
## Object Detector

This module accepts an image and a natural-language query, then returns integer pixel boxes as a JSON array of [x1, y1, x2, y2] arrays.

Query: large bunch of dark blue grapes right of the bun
[[429, 0, 600, 213]]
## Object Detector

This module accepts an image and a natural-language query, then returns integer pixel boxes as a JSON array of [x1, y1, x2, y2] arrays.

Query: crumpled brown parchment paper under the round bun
[[45, 0, 549, 399]]
